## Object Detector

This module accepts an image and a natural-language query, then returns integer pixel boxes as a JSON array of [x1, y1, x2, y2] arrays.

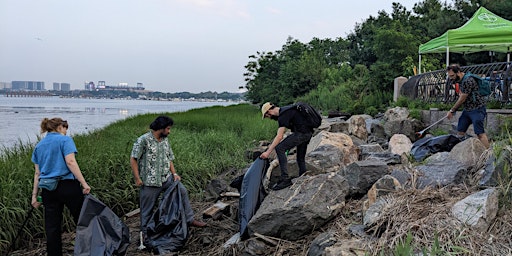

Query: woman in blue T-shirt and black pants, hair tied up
[[32, 118, 91, 256]]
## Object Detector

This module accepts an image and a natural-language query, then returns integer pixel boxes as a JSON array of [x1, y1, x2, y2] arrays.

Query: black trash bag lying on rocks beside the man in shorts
[[411, 134, 462, 162]]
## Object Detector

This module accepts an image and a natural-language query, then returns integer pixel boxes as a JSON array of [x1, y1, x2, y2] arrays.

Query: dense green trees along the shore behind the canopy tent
[[244, 0, 512, 114]]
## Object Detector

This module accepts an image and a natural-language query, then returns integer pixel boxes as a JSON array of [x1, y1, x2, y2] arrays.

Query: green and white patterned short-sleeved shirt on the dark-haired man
[[131, 131, 174, 187]]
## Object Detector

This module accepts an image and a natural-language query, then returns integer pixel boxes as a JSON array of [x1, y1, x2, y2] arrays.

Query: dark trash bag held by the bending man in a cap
[[239, 158, 268, 238]]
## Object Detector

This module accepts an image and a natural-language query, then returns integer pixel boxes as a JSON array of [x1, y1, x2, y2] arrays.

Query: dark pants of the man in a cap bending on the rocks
[[276, 132, 312, 179]]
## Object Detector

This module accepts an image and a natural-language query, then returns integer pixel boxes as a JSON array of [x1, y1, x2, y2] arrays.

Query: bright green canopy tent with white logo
[[418, 7, 512, 73]]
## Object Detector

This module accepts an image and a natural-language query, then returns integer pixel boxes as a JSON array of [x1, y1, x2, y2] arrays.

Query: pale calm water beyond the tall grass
[[0, 95, 235, 148]]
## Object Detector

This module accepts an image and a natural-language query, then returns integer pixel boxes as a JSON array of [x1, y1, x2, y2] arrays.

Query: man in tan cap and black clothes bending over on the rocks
[[260, 102, 313, 190]]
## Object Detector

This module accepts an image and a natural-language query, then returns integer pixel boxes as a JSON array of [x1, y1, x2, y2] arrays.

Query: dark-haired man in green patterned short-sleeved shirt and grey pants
[[130, 116, 206, 246]]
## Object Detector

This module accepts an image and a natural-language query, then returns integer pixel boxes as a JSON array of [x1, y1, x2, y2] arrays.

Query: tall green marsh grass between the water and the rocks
[[0, 104, 277, 252]]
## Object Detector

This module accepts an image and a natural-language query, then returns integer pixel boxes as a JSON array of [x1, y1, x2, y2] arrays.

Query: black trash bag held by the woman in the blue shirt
[[74, 195, 130, 256]]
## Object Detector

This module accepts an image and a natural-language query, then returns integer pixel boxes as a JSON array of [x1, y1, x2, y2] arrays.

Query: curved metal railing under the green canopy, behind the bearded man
[[409, 62, 512, 103]]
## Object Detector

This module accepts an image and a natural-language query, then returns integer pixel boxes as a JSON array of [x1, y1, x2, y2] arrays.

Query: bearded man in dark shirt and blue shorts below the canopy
[[446, 64, 490, 148]]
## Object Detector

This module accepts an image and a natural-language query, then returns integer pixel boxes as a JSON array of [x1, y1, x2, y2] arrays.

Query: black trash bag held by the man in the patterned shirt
[[147, 182, 189, 254]]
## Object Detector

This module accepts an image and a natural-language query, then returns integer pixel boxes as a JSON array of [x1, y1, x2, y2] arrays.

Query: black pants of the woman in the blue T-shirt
[[41, 180, 84, 256]]
